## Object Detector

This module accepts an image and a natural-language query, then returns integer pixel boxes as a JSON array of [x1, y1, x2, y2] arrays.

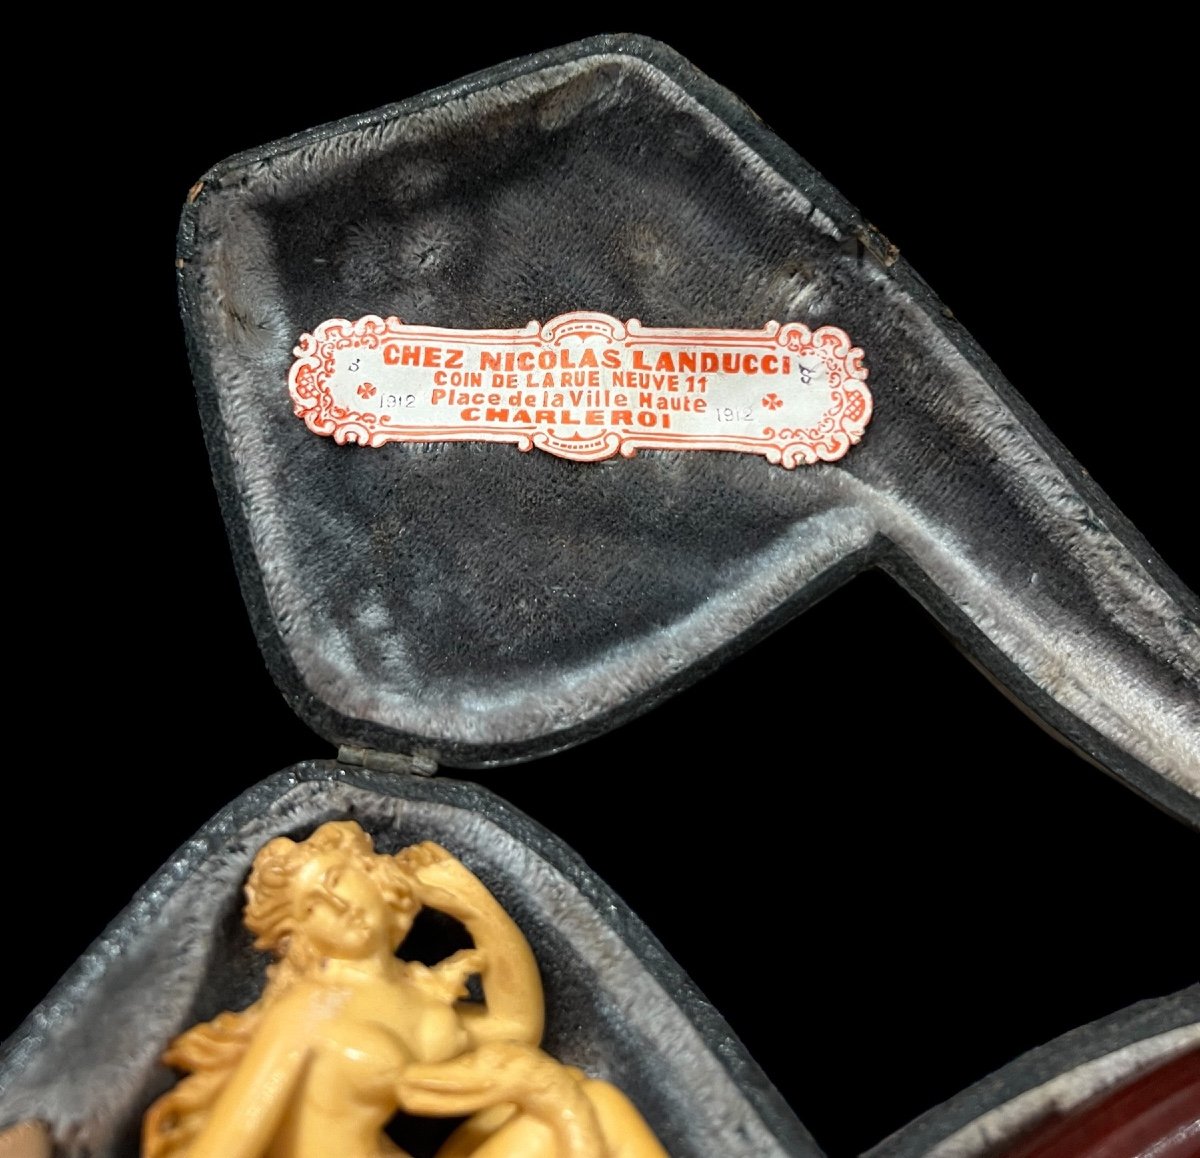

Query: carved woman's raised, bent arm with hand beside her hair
[[398, 841, 545, 1046]]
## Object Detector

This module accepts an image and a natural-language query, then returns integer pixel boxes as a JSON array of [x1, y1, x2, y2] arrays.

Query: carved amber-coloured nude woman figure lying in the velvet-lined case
[[143, 821, 666, 1158]]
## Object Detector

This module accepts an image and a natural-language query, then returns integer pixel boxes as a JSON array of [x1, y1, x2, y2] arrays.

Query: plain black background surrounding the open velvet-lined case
[[7, 20, 1200, 1156]]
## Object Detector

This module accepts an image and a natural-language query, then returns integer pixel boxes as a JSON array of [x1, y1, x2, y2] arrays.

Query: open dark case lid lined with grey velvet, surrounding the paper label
[[179, 37, 1200, 822]]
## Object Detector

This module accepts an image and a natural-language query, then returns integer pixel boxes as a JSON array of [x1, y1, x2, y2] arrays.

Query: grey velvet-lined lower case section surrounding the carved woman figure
[[0, 763, 820, 1158]]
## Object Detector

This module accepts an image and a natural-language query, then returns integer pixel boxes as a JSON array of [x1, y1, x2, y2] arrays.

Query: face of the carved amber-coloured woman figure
[[295, 852, 395, 961]]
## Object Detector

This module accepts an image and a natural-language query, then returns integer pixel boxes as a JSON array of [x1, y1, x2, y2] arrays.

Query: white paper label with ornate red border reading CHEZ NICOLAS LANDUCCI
[[288, 313, 871, 467]]
